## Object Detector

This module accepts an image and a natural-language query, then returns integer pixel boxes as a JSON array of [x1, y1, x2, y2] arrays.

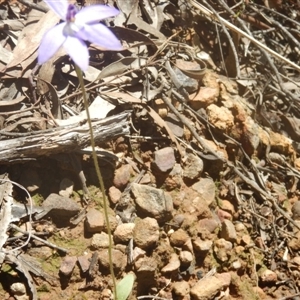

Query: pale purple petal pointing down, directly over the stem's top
[[64, 36, 89, 71]]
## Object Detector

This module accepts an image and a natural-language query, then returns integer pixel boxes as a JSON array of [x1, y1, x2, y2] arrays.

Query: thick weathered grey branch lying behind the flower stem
[[0, 112, 129, 164]]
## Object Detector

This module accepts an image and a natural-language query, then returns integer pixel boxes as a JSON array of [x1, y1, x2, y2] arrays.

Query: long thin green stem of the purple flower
[[75, 65, 118, 300]]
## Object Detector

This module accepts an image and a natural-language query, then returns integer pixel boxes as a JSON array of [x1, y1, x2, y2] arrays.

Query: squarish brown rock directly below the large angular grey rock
[[133, 218, 159, 249]]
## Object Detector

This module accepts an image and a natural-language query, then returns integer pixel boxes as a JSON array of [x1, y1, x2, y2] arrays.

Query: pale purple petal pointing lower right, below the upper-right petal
[[77, 24, 123, 50]]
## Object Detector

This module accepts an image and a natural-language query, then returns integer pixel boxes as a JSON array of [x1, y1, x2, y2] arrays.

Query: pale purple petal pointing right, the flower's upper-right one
[[75, 4, 119, 24]]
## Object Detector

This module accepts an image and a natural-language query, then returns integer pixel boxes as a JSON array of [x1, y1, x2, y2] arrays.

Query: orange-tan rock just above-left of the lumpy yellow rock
[[189, 87, 219, 110]]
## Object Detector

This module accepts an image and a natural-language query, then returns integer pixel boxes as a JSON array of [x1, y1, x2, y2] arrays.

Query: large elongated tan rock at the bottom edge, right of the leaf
[[191, 273, 231, 300]]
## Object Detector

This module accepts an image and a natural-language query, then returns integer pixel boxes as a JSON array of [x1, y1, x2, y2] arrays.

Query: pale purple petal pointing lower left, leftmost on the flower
[[38, 23, 66, 65]]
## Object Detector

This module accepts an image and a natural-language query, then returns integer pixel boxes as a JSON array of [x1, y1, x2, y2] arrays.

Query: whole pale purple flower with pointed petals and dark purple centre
[[38, 0, 122, 71]]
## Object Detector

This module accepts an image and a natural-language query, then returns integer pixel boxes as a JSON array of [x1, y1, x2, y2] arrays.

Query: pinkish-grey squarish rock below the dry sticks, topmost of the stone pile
[[153, 147, 176, 172]]
